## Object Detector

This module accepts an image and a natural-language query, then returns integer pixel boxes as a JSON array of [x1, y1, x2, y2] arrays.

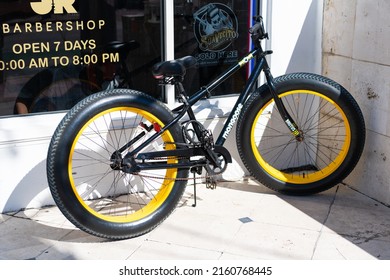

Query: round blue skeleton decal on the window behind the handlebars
[[194, 3, 238, 51]]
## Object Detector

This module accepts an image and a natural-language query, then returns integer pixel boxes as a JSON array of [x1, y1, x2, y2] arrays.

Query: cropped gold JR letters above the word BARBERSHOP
[[30, 0, 77, 15]]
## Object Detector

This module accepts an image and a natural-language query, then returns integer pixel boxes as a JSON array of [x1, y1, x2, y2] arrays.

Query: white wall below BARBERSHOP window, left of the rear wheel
[[0, 114, 64, 213]]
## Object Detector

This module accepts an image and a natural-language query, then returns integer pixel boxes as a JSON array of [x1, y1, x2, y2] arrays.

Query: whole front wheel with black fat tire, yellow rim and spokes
[[236, 73, 365, 195]]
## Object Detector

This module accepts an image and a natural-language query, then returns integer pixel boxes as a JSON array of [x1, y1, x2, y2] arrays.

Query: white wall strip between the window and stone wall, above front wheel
[[266, 0, 323, 77]]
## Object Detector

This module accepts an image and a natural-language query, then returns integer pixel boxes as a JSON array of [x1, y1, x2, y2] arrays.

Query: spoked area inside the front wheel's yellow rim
[[254, 91, 347, 182]]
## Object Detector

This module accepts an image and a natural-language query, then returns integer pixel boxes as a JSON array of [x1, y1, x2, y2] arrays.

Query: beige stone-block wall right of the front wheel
[[323, 0, 390, 205]]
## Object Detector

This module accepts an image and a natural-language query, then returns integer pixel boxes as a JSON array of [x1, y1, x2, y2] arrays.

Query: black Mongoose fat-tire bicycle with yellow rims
[[47, 17, 365, 239]]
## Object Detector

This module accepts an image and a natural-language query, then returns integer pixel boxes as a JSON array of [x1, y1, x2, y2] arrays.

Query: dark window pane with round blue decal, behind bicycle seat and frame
[[175, 0, 256, 95]]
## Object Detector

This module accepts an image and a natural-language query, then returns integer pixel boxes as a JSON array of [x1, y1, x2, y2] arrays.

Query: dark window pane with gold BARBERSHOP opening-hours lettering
[[0, 0, 161, 116]]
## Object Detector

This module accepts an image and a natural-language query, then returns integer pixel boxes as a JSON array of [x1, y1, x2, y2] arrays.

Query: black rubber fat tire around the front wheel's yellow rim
[[236, 73, 365, 195]]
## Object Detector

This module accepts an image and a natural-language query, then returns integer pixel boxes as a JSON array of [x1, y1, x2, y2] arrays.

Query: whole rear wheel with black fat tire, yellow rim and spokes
[[47, 89, 188, 239]]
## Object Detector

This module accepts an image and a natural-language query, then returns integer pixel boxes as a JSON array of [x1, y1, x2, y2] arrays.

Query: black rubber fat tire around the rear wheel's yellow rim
[[47, 89, 188, 239]]
